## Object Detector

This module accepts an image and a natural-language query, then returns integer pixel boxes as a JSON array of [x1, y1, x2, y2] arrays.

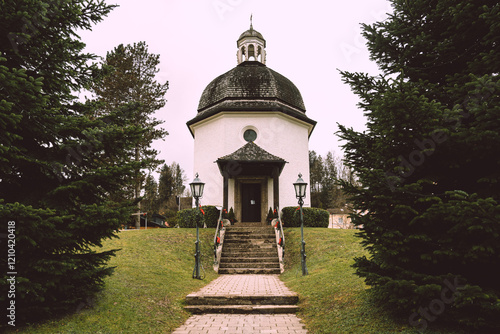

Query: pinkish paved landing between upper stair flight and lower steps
[[188, 275, 297, 297]]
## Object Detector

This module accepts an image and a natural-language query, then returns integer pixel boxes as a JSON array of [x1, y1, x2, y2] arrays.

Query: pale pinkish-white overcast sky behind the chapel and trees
[[80, 0, 391, 181]]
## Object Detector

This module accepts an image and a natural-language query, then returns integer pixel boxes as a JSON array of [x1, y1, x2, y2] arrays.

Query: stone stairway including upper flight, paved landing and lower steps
[[184, 223, 299, 314]]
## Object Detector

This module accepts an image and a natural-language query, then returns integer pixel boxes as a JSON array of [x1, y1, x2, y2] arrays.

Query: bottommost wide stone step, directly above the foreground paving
[[184, 305, 299, 314]]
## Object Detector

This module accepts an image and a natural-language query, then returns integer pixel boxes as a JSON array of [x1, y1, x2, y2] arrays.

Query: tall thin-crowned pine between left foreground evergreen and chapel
[[92, 42, 168, 227]]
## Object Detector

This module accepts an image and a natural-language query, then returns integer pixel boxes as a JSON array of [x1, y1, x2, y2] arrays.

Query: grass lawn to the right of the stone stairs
[[281, 228, 465, 334]]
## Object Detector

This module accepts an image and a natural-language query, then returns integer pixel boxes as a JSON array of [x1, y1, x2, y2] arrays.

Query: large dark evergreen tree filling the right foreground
[[340, 0, 500, 332]]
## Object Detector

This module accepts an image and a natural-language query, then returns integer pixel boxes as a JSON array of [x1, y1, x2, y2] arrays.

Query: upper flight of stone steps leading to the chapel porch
[[219, 223, 281, 275]]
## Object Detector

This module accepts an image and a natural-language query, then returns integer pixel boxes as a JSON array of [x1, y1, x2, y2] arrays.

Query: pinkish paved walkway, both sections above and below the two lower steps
[[173, 275, 307, 334]]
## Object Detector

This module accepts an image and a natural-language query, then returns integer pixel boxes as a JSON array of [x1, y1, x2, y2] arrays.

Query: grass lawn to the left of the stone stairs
[[9, 228, 217, 334]]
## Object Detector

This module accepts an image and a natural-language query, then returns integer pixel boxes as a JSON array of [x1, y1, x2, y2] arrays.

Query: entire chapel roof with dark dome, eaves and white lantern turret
[[187, 24, 316, 136]]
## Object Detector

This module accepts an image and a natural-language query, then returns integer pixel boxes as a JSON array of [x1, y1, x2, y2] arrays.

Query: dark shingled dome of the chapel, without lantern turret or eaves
[[198, 61, 306, 113]]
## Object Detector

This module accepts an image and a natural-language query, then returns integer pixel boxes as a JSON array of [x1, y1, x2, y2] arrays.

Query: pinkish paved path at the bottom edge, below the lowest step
[[173, 314, 307, 334]]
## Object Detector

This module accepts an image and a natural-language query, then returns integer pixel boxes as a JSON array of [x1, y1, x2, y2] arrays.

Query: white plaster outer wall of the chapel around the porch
[[191, 112, 311, 207]]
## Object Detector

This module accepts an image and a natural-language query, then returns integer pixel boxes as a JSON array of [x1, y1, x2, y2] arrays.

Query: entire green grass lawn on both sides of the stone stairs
[[9, 228, 468, 334]]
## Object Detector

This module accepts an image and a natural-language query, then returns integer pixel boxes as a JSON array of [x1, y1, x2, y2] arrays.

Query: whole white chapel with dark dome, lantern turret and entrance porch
[[187, 24, 316, 222]]
